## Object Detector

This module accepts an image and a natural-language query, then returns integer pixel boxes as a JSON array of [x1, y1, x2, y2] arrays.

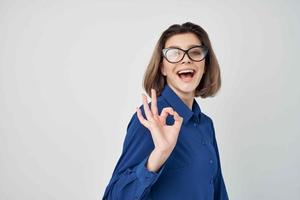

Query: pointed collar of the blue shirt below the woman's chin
[[161, 84, 201, 124]]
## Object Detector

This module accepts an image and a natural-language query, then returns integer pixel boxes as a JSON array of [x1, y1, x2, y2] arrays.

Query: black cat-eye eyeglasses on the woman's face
[[162, 45, 208, 63]]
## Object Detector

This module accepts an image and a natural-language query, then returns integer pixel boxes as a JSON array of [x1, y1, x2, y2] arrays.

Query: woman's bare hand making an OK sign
[[137, 89, 183, 154]]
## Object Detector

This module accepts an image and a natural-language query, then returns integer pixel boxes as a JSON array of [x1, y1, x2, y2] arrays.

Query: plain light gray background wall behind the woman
[[0, 0, 300, 200]]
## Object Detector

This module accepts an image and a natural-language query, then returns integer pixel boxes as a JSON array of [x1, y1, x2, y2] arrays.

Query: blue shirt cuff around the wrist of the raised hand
[[136, 156, 165, 187]]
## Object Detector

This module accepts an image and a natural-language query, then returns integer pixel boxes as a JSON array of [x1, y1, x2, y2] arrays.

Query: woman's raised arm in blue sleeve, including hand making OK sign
[[103, 89, 183, 200]]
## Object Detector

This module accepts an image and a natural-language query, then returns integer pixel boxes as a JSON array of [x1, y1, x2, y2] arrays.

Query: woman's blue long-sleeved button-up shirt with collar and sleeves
[[102, 84, 228, 200]]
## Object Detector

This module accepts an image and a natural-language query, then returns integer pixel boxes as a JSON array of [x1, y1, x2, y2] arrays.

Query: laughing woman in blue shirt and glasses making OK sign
[[103, 22, 228, 200]]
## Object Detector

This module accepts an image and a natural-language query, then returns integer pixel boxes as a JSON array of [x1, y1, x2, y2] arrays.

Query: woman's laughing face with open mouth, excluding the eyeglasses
[[161, 33, 205, 97]]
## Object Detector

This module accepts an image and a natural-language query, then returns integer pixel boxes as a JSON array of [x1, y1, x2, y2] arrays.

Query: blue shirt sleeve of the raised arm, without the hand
[[102, 109, 165, 200]]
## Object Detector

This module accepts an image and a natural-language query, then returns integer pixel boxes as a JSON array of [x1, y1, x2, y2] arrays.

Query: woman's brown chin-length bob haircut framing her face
[[143, 22, 221, 98]]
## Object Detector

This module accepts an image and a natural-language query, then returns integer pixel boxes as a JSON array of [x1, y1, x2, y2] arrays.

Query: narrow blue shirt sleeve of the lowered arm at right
[[210, 119, 229, 200]]
